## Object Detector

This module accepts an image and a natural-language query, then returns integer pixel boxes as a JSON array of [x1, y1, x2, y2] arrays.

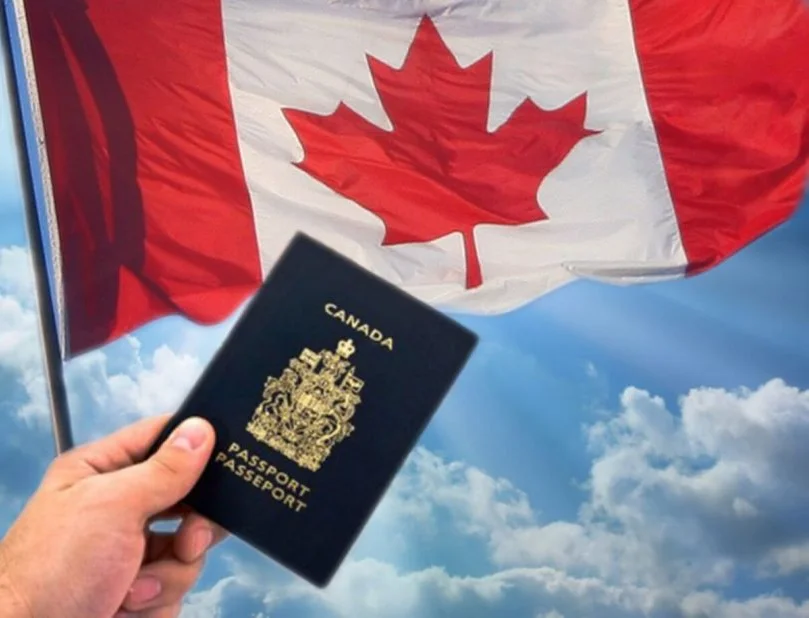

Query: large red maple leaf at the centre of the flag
[[284, 17, 598, 288]]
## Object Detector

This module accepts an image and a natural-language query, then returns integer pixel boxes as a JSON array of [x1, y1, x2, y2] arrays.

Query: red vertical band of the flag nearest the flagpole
[[25, 0, 261, 356]]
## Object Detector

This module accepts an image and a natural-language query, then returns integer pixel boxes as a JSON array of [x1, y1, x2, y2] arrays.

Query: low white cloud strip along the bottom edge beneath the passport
[[188, 558, 655, 618]]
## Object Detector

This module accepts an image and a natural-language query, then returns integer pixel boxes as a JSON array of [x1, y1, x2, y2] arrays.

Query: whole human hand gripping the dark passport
[[0, 416, 225, 618]]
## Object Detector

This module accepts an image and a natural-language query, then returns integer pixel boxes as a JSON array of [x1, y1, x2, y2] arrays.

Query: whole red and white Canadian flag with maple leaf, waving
[[15, 0, 809, 356]]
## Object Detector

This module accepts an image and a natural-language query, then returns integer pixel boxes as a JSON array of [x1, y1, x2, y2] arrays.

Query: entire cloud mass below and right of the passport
[[186, 380, 809, 618]]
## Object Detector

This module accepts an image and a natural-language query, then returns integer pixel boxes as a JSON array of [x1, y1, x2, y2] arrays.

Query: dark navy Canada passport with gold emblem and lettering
[[151, 233, 477, 587]]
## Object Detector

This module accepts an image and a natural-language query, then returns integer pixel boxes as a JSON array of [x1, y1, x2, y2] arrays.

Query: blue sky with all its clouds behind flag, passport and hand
[[0, 22, 809, 618]]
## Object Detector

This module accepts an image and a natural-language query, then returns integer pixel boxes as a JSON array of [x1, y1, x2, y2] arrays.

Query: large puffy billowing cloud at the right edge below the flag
[[576, 380, 809, 585]]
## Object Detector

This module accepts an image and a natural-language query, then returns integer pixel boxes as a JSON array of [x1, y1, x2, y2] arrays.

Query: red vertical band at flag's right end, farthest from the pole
[[630, 0, 809, 274]]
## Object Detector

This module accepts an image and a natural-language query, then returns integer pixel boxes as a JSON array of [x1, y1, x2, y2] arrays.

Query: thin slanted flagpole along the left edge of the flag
[[0, 0, 73, 455]]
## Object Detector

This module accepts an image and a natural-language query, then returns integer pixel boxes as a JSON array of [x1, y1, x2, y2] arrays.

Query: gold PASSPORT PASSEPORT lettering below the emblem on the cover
[[214, 442, 309, 513]]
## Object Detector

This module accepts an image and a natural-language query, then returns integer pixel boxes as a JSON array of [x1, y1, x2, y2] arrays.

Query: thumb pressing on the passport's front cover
[[108, 417, 215, 520]]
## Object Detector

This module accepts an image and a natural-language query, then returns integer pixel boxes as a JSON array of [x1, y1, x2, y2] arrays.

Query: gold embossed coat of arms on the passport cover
[[247, 339, 364, 471]]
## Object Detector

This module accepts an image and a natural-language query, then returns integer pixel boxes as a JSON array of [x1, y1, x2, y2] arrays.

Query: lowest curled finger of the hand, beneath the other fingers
[[121, 559, 205, 612]]
